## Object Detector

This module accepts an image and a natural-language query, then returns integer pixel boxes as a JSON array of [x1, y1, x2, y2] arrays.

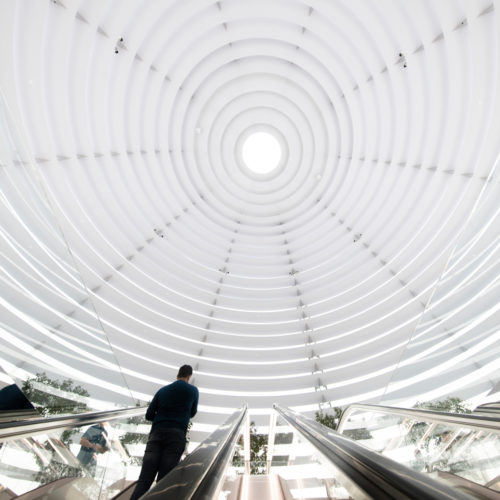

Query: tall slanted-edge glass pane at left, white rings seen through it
[[0, 91, 135, 415]]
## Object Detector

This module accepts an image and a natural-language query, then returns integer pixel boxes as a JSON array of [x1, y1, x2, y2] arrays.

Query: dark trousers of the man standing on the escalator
[[130, 428, 186, 500]]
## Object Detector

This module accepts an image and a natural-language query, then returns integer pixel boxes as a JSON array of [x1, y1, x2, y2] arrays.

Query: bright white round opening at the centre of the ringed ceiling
[[241, 132, 282, 174]]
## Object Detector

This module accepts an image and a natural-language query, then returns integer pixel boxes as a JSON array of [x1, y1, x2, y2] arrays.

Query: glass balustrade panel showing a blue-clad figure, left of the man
[[0, 417, 150, 500]]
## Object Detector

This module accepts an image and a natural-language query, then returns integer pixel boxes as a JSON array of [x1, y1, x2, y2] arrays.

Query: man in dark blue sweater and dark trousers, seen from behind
[[130, 365, 198, 500]]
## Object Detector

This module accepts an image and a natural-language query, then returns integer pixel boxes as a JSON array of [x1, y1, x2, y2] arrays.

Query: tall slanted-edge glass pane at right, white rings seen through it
[[381, 160, 500, 406]]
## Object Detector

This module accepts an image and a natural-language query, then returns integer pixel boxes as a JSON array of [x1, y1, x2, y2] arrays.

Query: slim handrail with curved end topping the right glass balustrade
[[337, 404, 500, 432]]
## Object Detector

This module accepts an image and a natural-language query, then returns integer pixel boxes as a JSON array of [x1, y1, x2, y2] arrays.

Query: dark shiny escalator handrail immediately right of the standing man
[[141, 404, 247, 500]]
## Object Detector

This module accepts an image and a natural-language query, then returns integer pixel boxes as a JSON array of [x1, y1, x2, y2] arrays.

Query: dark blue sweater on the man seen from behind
[[146, 380, 198, 432]]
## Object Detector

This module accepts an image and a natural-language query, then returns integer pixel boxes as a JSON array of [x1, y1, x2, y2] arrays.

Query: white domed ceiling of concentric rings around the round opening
[[0, 0, 500, 430]]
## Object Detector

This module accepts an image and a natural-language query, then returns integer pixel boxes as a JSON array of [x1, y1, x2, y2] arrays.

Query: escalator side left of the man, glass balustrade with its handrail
[[0, 407, 149, 500]]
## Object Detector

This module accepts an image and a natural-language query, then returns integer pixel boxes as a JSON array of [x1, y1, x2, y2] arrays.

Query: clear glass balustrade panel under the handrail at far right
[[342, 410, 500, 489]]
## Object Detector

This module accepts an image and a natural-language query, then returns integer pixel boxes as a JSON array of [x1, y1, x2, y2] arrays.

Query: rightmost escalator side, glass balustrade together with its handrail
[[338, 403, 500, 500]]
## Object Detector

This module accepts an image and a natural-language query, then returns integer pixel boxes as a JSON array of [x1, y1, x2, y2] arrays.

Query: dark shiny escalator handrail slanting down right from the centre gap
[[274, 405, 472, 500]]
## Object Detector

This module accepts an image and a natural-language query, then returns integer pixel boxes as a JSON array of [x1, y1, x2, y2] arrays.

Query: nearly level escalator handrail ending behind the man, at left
[[0, 406, 147, 442]]
